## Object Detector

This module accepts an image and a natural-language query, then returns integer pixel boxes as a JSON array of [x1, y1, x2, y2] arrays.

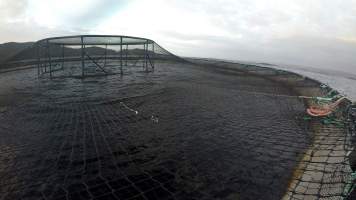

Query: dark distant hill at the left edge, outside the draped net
[[0, 42, 33, 63]]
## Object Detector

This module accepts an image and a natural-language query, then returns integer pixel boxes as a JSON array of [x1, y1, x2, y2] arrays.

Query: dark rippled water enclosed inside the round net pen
[[0, 63, 310, 199]]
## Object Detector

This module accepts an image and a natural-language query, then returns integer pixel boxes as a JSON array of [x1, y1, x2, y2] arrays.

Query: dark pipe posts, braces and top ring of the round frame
[[35, 35, 155, 78]]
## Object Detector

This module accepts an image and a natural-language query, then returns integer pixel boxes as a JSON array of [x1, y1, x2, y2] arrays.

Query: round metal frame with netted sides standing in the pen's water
[[35, 35, 156, 78]]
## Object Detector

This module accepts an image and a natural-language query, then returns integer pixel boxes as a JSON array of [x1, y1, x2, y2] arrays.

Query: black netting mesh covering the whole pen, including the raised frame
[[0, 36, 356, 200]]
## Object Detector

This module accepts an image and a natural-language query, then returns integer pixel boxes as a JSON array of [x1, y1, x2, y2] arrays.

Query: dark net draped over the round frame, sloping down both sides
[[7, 35, 177, 78]]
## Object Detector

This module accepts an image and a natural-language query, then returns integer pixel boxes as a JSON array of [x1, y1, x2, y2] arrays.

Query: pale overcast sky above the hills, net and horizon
[[0, 0, 356, 74]]
